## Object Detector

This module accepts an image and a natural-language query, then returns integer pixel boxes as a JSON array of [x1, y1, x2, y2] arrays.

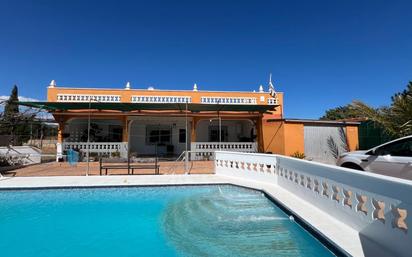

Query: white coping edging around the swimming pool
[[0, 174, 364, 256]]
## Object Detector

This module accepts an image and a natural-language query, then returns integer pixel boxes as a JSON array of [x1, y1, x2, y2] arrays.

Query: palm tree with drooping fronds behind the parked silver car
[[352, 82, 412, 137]]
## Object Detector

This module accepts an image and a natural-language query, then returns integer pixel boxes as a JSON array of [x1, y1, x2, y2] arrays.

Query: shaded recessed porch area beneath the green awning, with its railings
[[61, 116, 258, 160]]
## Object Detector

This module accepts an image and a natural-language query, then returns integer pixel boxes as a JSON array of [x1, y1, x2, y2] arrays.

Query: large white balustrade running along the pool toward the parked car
[[215, 151, 412, 256]]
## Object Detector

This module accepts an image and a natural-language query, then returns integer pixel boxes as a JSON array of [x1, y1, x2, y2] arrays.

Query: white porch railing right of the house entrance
[[190, 142, 257, 160]]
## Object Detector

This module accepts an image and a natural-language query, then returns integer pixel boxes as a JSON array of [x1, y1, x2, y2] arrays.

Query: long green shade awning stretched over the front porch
[[18, 102, 278, 112]]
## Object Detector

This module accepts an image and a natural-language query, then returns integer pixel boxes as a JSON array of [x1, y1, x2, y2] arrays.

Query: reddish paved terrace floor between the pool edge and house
[[3, 161, 214, 177]]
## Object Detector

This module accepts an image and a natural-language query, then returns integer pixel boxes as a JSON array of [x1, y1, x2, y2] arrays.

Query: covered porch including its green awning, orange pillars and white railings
[[20, 101, 273, 160]]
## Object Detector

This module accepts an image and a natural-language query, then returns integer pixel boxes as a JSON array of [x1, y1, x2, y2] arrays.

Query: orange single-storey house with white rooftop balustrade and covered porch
[[21, 81, 357, 161]]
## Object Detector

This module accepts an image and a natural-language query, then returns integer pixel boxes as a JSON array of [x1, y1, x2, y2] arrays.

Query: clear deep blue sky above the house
[[0, 0, 412, 118]]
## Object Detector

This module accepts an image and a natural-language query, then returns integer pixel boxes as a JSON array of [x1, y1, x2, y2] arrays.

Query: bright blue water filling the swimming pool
[[0, 186, 332, 257]]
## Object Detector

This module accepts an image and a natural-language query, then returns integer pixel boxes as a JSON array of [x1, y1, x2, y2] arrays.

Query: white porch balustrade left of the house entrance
[[63, 142, 127, 157]]
